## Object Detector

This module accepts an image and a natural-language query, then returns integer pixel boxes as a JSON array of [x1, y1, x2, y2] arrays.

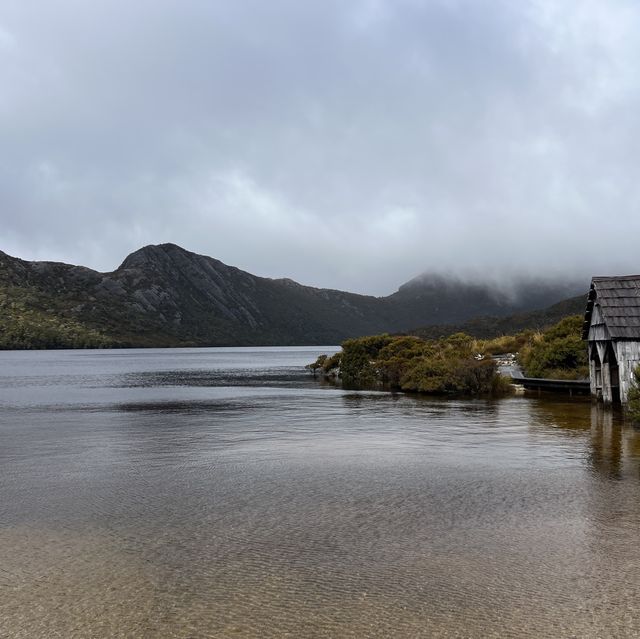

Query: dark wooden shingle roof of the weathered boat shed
[[582, 275, 640, 340]]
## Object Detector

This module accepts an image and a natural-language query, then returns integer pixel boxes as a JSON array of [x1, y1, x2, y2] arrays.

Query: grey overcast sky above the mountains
[[0, 0, 640, 294]]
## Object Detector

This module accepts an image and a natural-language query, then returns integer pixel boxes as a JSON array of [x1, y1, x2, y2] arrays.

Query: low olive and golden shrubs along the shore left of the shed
[[308, 315, 588, 395]]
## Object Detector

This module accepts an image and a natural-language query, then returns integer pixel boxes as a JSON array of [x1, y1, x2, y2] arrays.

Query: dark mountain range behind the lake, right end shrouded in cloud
[[0, 244, 588, 348]]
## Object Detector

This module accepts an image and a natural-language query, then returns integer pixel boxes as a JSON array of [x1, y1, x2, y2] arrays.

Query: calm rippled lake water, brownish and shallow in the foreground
[[0, 348, 640, 639]]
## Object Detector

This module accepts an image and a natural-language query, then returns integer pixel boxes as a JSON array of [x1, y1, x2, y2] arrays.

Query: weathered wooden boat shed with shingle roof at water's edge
[[582, 275, 640, 404]]
